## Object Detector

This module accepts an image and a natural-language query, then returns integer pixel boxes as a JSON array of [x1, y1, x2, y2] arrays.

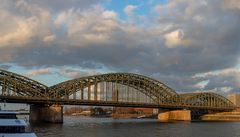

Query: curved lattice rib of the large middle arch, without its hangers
[[49, 73, 179, 104]]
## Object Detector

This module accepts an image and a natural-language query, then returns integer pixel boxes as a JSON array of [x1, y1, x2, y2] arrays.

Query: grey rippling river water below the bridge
[[24, 116, 240, 137]]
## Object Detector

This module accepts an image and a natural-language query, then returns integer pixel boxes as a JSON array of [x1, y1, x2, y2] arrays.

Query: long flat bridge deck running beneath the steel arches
[[0, 96, 235, 111]]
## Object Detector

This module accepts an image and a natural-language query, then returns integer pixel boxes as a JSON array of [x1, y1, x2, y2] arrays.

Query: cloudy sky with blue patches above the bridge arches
[[0, 0, 240, 94]]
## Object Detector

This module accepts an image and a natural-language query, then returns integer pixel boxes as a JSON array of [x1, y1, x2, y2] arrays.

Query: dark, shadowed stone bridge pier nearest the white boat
[[29, 104, 63, 123]]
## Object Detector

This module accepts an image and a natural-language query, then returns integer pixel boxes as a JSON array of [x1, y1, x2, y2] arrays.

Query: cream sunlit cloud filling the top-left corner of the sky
[[0, 0, 50, 47]]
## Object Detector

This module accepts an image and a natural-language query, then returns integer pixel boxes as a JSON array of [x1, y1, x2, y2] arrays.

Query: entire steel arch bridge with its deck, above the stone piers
[[0, 69, 235, 122]]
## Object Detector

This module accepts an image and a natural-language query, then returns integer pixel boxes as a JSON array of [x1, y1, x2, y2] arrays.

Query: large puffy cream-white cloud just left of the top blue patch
[[54, 6, 119, 46]]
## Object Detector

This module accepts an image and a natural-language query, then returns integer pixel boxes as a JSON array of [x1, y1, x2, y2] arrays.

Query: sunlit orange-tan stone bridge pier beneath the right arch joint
[[158, 110, 191, 122]]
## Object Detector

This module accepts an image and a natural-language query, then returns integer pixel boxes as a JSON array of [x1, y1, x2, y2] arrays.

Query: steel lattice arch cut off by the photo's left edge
[[0, 69, 48, 98]]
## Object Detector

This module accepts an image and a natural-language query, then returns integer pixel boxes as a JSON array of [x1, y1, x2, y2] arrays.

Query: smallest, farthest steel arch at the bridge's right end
[[180, 92, 235, 108]]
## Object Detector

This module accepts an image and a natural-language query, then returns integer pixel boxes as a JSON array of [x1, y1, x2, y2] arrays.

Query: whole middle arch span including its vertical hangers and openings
[[49, 73, 179, 104]]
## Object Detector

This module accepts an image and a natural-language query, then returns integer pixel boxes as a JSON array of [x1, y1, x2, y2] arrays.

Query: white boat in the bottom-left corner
[[0, 111, 37, 137]]
